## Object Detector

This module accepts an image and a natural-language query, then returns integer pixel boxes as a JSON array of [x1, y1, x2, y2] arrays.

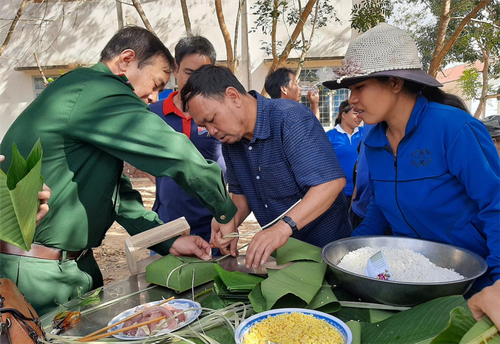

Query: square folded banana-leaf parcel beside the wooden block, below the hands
[[146, 254, 217, 293]]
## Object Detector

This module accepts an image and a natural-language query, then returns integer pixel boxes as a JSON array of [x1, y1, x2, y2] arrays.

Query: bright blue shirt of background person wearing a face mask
[[326, 125, 363, 196]]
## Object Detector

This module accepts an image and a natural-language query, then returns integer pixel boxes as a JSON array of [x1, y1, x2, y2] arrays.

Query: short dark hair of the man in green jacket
[[100, 26, 175, 68]]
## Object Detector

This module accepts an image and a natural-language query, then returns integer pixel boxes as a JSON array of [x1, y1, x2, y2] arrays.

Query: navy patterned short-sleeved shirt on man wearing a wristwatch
[[222, 91, 352, 247]]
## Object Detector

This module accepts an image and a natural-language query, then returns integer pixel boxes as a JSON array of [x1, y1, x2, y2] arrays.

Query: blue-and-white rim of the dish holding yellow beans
[[234, 308, 352, 344]]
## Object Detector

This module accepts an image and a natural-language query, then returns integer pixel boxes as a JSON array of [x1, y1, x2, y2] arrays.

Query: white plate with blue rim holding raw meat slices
[[108, 299, 201, 340]]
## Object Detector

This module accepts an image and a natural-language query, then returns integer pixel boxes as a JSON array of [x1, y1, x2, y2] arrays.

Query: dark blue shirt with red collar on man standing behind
[[150, 92, 226, 241]]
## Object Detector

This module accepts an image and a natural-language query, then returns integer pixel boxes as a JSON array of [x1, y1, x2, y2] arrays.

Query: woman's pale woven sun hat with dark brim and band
[[323, 23, 443, 90]]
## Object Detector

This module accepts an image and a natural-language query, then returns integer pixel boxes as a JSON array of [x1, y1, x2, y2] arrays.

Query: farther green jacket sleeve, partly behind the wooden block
[[116, 174, 178, 255]]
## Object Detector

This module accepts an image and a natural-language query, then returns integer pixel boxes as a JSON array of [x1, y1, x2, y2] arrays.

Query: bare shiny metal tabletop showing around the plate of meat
[[40, 273, 213, 336]]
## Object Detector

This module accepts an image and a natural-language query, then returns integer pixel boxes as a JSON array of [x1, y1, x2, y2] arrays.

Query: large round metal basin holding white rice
[[321, 236, 487, 306]]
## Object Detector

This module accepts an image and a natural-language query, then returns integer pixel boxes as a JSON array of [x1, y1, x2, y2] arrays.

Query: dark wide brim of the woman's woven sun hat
[[323, 69, 443, 90]]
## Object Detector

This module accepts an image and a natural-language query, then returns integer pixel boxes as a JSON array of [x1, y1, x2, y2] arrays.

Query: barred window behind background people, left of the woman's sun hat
[[299, 67, 349, 128]]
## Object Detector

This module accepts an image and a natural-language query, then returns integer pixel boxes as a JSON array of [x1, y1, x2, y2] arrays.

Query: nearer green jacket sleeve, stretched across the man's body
[[68, 77, 236, 223]]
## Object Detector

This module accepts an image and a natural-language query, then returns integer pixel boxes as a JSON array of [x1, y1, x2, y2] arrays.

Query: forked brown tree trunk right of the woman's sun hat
[[429, 0, 491, 77]]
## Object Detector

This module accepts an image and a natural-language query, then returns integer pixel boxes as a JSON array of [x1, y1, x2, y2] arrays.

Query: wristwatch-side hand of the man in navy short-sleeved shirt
[[246, 221, 292, 269]]
